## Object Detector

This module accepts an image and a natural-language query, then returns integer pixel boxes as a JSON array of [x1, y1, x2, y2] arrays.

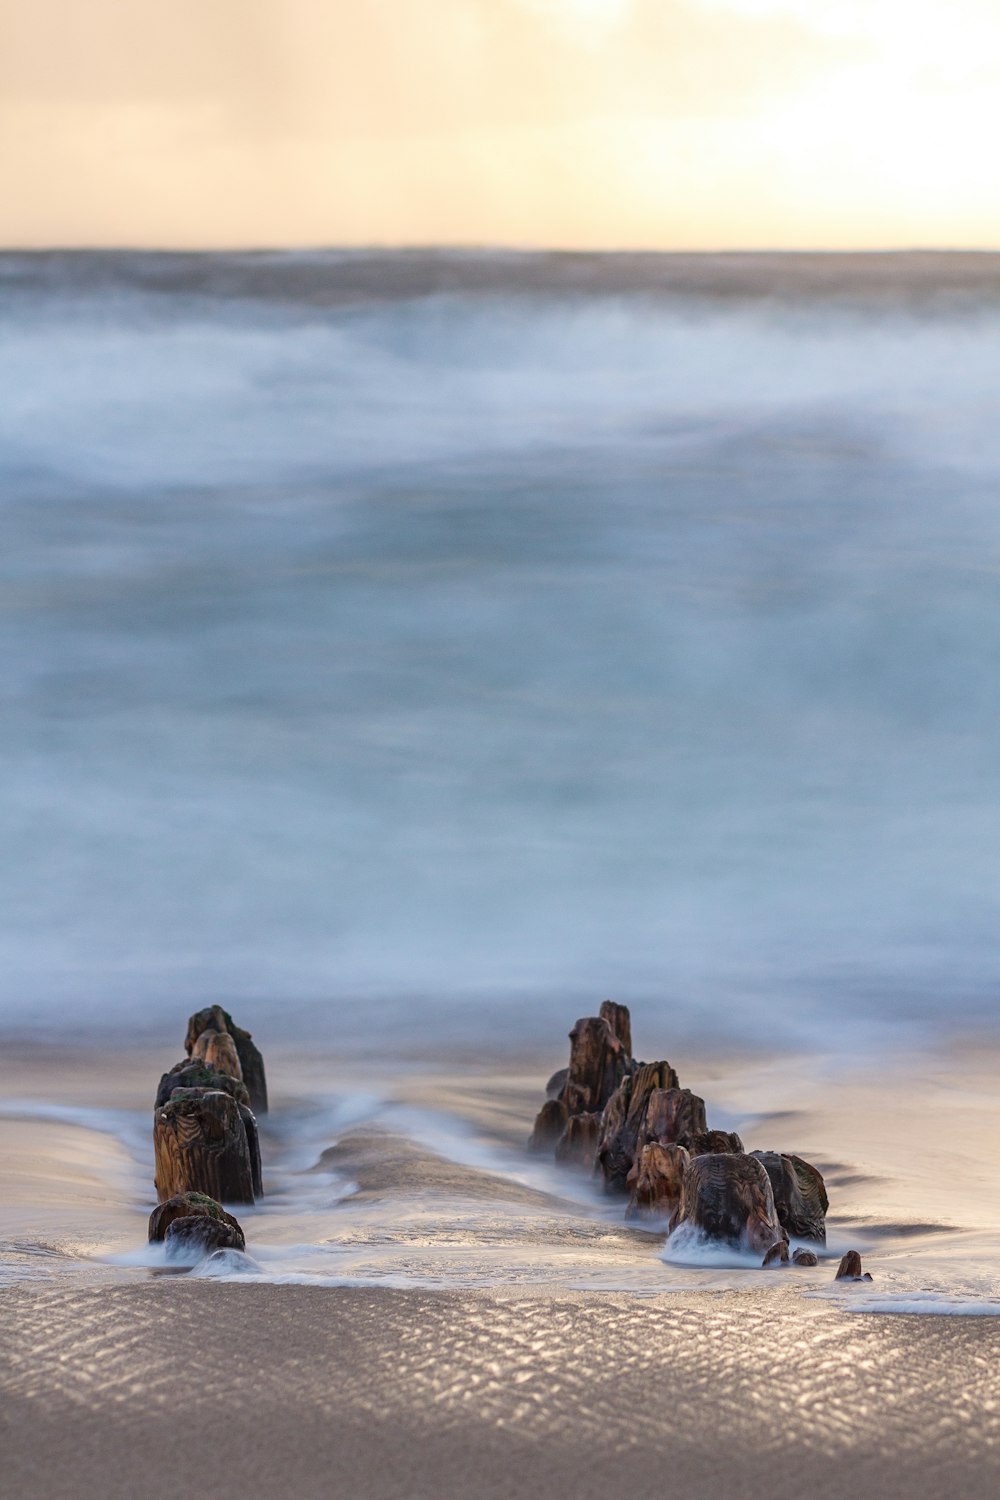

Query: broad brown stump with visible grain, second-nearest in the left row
[[153, 1089, 253, 1203]]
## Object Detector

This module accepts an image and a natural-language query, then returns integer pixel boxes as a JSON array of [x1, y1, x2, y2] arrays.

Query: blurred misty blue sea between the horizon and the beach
[[0, 255, 1000, 1061]]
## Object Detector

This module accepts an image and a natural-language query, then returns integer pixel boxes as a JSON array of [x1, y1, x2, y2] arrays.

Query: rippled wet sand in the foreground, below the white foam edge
[[0, 1278, 1000, 1500]]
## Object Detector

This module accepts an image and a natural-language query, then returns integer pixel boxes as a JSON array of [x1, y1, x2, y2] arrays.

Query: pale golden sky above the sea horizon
[[0, 0, 1000, 249]]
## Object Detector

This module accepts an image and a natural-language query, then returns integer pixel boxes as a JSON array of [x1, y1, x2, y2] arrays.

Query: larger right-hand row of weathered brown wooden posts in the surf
[[529, 1001, 871, 1280]]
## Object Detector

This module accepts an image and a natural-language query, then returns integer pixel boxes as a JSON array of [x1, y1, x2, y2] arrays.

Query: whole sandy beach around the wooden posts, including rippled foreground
[[0, 1047, 1000, 1500]]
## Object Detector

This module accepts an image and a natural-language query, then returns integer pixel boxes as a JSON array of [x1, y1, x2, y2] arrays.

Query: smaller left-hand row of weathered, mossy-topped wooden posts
[[150, 1005, 267, 1262]]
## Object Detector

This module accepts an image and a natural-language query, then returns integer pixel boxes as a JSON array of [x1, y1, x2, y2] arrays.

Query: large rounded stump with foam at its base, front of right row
[[670, 1152, 784, 1256]]
